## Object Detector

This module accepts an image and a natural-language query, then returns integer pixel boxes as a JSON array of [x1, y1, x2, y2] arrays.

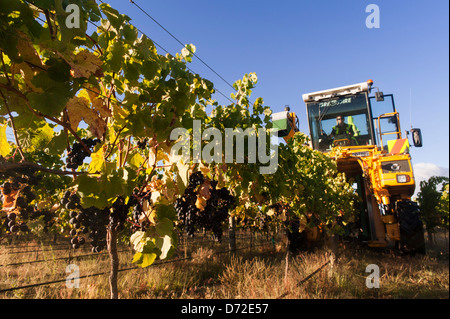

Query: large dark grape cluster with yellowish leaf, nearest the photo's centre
[[175, 172, 235, 241]]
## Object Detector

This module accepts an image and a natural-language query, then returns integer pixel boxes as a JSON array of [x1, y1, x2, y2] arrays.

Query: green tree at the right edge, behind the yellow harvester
[[417, 176, 449, 242]]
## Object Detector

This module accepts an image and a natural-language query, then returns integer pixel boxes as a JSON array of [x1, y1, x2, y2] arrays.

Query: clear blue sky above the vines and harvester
[[103, 0, 449, 188]]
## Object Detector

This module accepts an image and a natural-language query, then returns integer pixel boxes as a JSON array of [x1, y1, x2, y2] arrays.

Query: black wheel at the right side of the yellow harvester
[[397, 201, 425, 254]]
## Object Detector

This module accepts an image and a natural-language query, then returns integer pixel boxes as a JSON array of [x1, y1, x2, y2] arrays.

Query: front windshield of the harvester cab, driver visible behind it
[[306, 93, 373, 152]]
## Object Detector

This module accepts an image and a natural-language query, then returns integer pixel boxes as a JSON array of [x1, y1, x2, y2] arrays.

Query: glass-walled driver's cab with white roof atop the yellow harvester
[[303, 80, 418, 152]]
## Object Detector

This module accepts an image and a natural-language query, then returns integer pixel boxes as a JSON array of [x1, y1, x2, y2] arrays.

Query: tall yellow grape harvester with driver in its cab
[[274, 80, 425, 253]]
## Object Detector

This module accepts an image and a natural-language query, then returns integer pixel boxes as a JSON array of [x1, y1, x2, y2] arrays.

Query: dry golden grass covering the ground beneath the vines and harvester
[[0, 230, 449, 299]]
